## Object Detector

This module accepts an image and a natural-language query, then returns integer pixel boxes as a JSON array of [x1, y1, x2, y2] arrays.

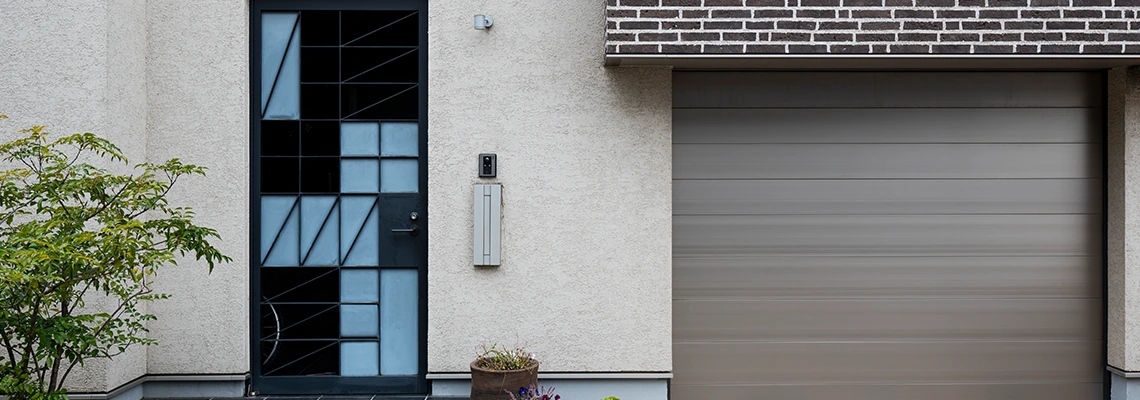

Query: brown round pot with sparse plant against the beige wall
[[471, 344, 538, 400]]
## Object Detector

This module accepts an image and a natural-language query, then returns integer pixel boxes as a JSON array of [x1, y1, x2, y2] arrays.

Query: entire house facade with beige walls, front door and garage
[[0, 0, 1140, 400]]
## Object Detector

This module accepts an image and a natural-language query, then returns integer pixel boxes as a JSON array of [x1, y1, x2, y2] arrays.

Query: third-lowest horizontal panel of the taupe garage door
[[673, 299, 1100, 342]]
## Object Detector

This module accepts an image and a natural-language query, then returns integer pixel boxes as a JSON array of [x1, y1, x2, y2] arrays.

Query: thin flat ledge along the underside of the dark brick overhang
[[605, 54, 1140, 71]]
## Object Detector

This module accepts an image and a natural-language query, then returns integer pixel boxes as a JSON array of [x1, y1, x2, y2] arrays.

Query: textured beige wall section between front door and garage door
[[428, 0, 673, 372]]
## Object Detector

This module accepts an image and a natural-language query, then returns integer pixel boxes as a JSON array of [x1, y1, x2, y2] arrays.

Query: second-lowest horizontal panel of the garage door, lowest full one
[[673, 341, 1104, 384]]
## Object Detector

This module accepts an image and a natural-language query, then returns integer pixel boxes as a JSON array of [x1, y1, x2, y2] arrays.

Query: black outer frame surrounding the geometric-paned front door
[[249, 0, 430, 394]]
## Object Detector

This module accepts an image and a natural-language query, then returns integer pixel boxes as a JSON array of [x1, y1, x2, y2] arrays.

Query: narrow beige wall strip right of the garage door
[[1106, 67, 1140, 370]]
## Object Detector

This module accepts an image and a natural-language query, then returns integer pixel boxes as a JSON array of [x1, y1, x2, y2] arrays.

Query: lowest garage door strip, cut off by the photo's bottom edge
[[669, 383, 1104, 400]]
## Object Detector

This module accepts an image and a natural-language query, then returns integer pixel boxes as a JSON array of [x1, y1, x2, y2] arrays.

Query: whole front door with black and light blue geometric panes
[[251, 0, 428, 394]]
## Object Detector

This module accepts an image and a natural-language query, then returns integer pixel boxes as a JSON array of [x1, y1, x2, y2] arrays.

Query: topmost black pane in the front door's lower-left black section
[[261, 266, 341, 304]]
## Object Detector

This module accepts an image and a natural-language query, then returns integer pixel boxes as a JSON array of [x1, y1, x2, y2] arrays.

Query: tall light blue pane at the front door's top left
[[261, 13, 301, 120]]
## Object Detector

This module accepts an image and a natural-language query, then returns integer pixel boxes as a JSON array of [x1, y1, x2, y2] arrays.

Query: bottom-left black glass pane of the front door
[[261, 341, 341, 376]]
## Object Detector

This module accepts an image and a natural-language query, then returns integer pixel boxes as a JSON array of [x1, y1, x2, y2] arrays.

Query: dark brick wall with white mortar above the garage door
[[605, 0, 1140, 55]]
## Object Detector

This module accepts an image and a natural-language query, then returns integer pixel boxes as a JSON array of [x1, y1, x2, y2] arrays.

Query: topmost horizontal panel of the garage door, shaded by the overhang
[[673, 72, 1102, 108]]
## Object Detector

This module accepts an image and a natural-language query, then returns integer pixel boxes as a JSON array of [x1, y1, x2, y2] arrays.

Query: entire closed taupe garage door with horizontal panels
[[673, 72, 1104, 400]]
